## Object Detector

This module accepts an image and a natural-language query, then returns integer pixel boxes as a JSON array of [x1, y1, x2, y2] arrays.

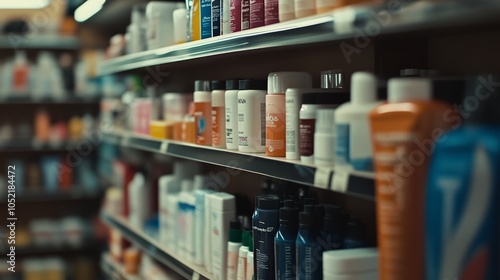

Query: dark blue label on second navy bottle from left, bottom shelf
[[275, 240, 297, 280]]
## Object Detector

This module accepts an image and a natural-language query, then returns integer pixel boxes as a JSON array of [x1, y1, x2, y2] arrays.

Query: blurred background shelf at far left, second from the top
[[0, 94, 101, 105]]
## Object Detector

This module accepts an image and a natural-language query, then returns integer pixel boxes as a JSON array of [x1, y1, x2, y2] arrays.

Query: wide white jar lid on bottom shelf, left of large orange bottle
[[323, 248, 378, 274]]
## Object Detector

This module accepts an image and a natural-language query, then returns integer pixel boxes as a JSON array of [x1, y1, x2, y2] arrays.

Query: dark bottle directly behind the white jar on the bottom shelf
[[321, 205, 345, 251]]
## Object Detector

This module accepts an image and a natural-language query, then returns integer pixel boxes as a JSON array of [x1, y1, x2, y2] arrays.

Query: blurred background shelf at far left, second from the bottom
[[0, 189, 103, 204]]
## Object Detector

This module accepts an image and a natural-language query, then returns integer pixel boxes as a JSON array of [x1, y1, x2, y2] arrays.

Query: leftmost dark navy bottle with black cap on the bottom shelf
[[252, 195, 280, 280]]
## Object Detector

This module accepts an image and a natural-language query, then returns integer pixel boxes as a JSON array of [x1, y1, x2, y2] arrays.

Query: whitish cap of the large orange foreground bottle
[[387, 78, 432, 103]]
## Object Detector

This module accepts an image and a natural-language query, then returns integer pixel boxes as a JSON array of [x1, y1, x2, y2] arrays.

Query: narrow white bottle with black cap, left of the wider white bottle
[[224, 80, 239, 150]]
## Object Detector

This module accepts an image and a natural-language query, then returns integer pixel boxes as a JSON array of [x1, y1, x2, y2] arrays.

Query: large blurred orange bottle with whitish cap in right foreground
[[370, 78, 453, 280]]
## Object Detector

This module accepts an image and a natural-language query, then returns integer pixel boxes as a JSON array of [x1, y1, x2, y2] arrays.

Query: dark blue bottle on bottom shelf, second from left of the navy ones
[[274, 200, 299, 280]]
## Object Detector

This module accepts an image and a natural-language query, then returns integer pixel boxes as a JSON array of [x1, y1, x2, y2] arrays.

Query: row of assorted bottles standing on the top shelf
[[107, 0, 380, 58]]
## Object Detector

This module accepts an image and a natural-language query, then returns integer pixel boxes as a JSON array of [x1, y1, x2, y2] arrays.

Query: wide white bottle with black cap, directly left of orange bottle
[[238, 80, 267, 153]]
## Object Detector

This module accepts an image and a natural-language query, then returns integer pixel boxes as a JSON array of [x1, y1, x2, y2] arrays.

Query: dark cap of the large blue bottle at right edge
[[462, 74, 500, 125]]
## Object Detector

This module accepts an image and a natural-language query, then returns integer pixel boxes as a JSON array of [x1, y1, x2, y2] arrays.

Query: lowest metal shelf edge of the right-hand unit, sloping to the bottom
[[101, 213, 211, 279]]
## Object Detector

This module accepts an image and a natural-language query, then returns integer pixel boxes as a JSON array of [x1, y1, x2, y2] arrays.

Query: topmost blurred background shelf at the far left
[[0, 34, 80, 50]]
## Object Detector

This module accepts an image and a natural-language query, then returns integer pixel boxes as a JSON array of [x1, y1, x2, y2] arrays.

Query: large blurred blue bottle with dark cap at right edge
[[425, 75, 500, 280]]
